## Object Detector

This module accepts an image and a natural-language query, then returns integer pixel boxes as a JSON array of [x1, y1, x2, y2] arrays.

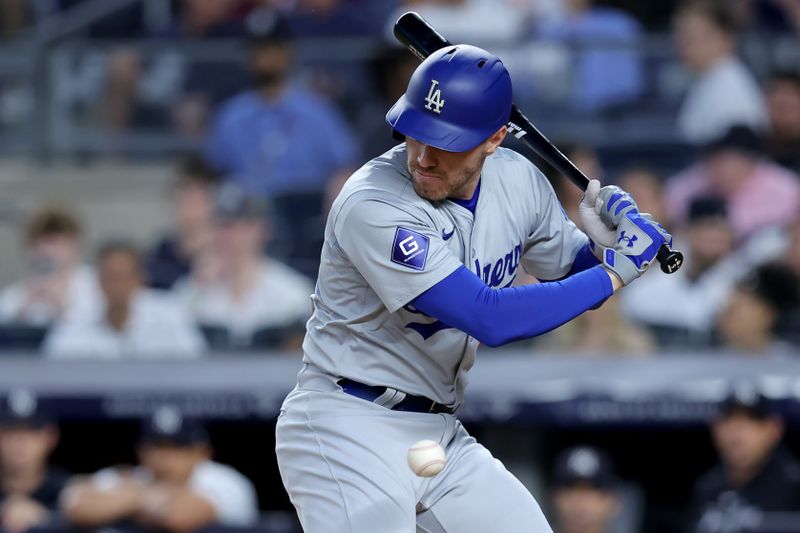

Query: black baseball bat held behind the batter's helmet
[[394, 11, 683, 274]]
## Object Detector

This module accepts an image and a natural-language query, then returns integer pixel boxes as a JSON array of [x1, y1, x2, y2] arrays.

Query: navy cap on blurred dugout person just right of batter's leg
[[553, 446, 617, 489]]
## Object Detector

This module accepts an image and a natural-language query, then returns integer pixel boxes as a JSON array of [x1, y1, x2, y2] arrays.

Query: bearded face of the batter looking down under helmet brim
[[406, 126, 507, 202]]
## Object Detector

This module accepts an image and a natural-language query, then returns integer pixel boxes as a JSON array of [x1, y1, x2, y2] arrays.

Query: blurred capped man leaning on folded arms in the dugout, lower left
[[62, 407, 258, 533]]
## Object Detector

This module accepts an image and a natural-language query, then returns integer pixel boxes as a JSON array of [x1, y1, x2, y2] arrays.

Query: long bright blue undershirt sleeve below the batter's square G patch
[[411, 266, 614, 346]]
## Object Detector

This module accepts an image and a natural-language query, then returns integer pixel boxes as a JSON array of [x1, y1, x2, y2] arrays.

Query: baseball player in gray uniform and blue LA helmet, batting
[[276, 45, 671, 533]]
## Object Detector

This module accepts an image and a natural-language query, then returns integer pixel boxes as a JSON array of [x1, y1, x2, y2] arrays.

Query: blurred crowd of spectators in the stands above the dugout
[[0, 0, 800, 358]]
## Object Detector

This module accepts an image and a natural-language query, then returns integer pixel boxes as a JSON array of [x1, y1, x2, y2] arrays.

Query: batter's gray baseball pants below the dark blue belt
[[276, 369, 552, 533]]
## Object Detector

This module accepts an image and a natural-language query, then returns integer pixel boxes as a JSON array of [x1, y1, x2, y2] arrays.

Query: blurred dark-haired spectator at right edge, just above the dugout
[[718, 264, 800, 355]]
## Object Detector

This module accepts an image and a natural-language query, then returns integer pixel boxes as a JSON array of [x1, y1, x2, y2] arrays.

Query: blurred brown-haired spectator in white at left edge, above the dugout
[[0, 207, 100, 326]]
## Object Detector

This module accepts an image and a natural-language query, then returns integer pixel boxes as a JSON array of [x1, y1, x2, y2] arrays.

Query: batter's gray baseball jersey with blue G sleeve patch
[[303, 144, 587, 405]]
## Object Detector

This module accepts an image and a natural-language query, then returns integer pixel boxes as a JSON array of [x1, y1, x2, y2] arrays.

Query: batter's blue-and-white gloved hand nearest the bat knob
[[594, 212, 672, 285]]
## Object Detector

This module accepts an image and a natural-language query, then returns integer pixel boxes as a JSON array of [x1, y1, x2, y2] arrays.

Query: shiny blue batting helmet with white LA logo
[[386, 44, 512, 152]]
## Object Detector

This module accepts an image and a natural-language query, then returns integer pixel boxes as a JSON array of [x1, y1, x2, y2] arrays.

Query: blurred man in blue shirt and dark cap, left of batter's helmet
[[207, 17, 357, 202]]
